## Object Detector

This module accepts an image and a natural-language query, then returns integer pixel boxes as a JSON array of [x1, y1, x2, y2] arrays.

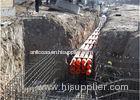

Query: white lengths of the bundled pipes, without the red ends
[[70, 15, 107, 65]]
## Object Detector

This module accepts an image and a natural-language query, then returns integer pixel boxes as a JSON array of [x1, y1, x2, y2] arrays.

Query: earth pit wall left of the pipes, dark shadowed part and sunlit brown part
[[23, 12, 98, 86]]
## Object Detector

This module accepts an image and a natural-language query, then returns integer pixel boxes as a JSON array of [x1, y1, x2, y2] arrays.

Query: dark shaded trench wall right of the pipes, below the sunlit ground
[[97, 30, 140, 100]]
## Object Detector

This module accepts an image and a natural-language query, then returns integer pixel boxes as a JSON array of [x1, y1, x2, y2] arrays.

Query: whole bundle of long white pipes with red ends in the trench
[[69, 15, 107, 76]]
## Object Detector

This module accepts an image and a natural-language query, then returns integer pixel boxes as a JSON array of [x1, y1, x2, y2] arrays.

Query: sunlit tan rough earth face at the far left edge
[[0, 22, 24, 95]]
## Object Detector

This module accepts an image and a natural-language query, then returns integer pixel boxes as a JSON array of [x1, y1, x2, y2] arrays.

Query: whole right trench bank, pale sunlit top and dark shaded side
[[97, 5, 140, 100]]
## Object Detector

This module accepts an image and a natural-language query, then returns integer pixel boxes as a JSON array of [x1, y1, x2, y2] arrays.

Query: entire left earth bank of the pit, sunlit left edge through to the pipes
[[1, 12, 99, 95]]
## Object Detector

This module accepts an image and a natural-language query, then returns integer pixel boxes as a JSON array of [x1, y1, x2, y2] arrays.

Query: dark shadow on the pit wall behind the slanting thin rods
[[24, 19, 70, 86]]
